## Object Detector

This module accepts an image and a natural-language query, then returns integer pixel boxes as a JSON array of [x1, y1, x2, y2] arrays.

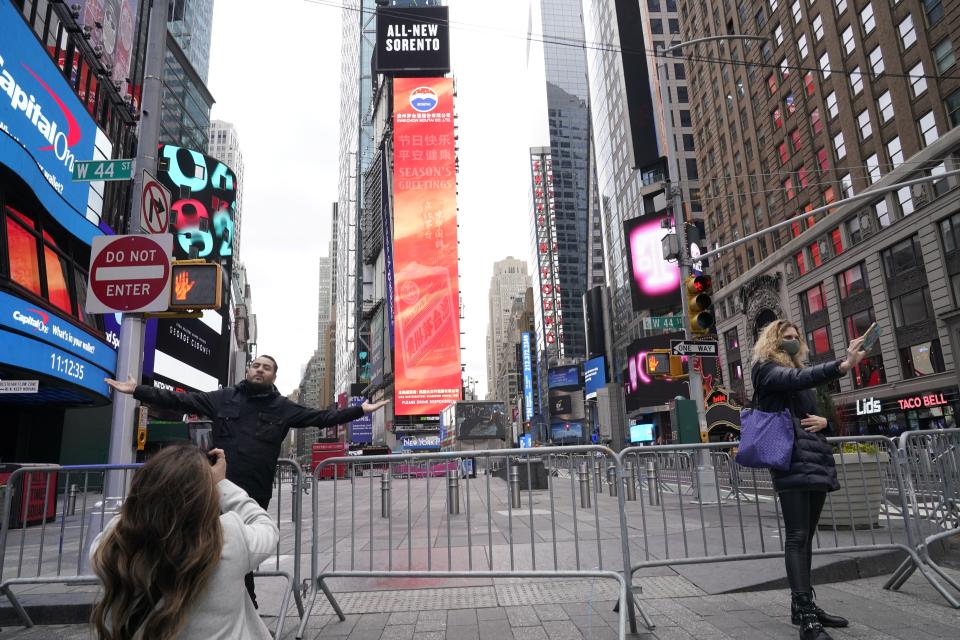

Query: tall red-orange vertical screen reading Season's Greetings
[[393, 78, 462, 415]]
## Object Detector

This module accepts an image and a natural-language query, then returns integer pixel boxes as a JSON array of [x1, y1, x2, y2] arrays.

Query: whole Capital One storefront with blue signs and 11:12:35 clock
[[0, 2, 116, 463]]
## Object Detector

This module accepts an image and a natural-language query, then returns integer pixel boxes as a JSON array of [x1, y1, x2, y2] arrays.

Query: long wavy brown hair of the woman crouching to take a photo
[[90, 445, 223, 640]]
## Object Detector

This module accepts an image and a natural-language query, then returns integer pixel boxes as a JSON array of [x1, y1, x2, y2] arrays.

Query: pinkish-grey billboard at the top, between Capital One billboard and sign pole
[[70, 0, 138, 100]]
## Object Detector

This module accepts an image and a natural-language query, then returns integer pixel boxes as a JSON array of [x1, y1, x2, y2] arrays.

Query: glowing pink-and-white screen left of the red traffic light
[[623, 214, 680, 311]]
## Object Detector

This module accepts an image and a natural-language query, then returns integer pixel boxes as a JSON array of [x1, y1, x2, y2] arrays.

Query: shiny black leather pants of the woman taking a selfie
[[779, 491, 827, 593]]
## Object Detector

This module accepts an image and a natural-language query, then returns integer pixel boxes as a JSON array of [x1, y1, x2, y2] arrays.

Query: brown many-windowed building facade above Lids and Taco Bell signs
[[681, 0, 960, 435]]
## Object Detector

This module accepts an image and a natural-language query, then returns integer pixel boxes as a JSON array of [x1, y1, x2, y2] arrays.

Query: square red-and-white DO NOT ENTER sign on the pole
[[86, 235, 173, 313]]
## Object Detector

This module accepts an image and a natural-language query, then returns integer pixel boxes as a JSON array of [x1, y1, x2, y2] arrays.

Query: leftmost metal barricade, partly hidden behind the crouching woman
[[0, 460, 303, 630]]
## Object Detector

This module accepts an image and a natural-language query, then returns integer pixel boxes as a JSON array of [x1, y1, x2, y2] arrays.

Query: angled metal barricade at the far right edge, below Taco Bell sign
[[884, 429, 960, 608]]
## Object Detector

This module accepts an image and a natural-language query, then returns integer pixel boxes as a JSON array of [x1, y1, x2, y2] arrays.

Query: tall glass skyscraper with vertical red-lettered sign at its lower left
[[527, 0, 603, 384]]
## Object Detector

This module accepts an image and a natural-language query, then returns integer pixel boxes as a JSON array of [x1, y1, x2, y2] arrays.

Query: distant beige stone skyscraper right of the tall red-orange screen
[[487, 256, 530, 402]]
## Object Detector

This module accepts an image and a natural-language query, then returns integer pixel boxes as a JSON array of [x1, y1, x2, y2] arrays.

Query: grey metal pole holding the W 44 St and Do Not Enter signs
[[103, 0, 169, 504]]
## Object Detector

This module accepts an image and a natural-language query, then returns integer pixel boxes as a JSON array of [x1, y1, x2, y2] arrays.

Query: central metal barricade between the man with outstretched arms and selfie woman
[[297, 446, 642, 638]]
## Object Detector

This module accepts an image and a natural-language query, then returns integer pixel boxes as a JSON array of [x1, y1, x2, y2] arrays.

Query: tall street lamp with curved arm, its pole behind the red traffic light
[[657, 34, 769, 503]]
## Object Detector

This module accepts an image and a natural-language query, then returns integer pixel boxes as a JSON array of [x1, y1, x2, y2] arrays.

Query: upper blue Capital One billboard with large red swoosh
[[0, 2, 97, 243]]
